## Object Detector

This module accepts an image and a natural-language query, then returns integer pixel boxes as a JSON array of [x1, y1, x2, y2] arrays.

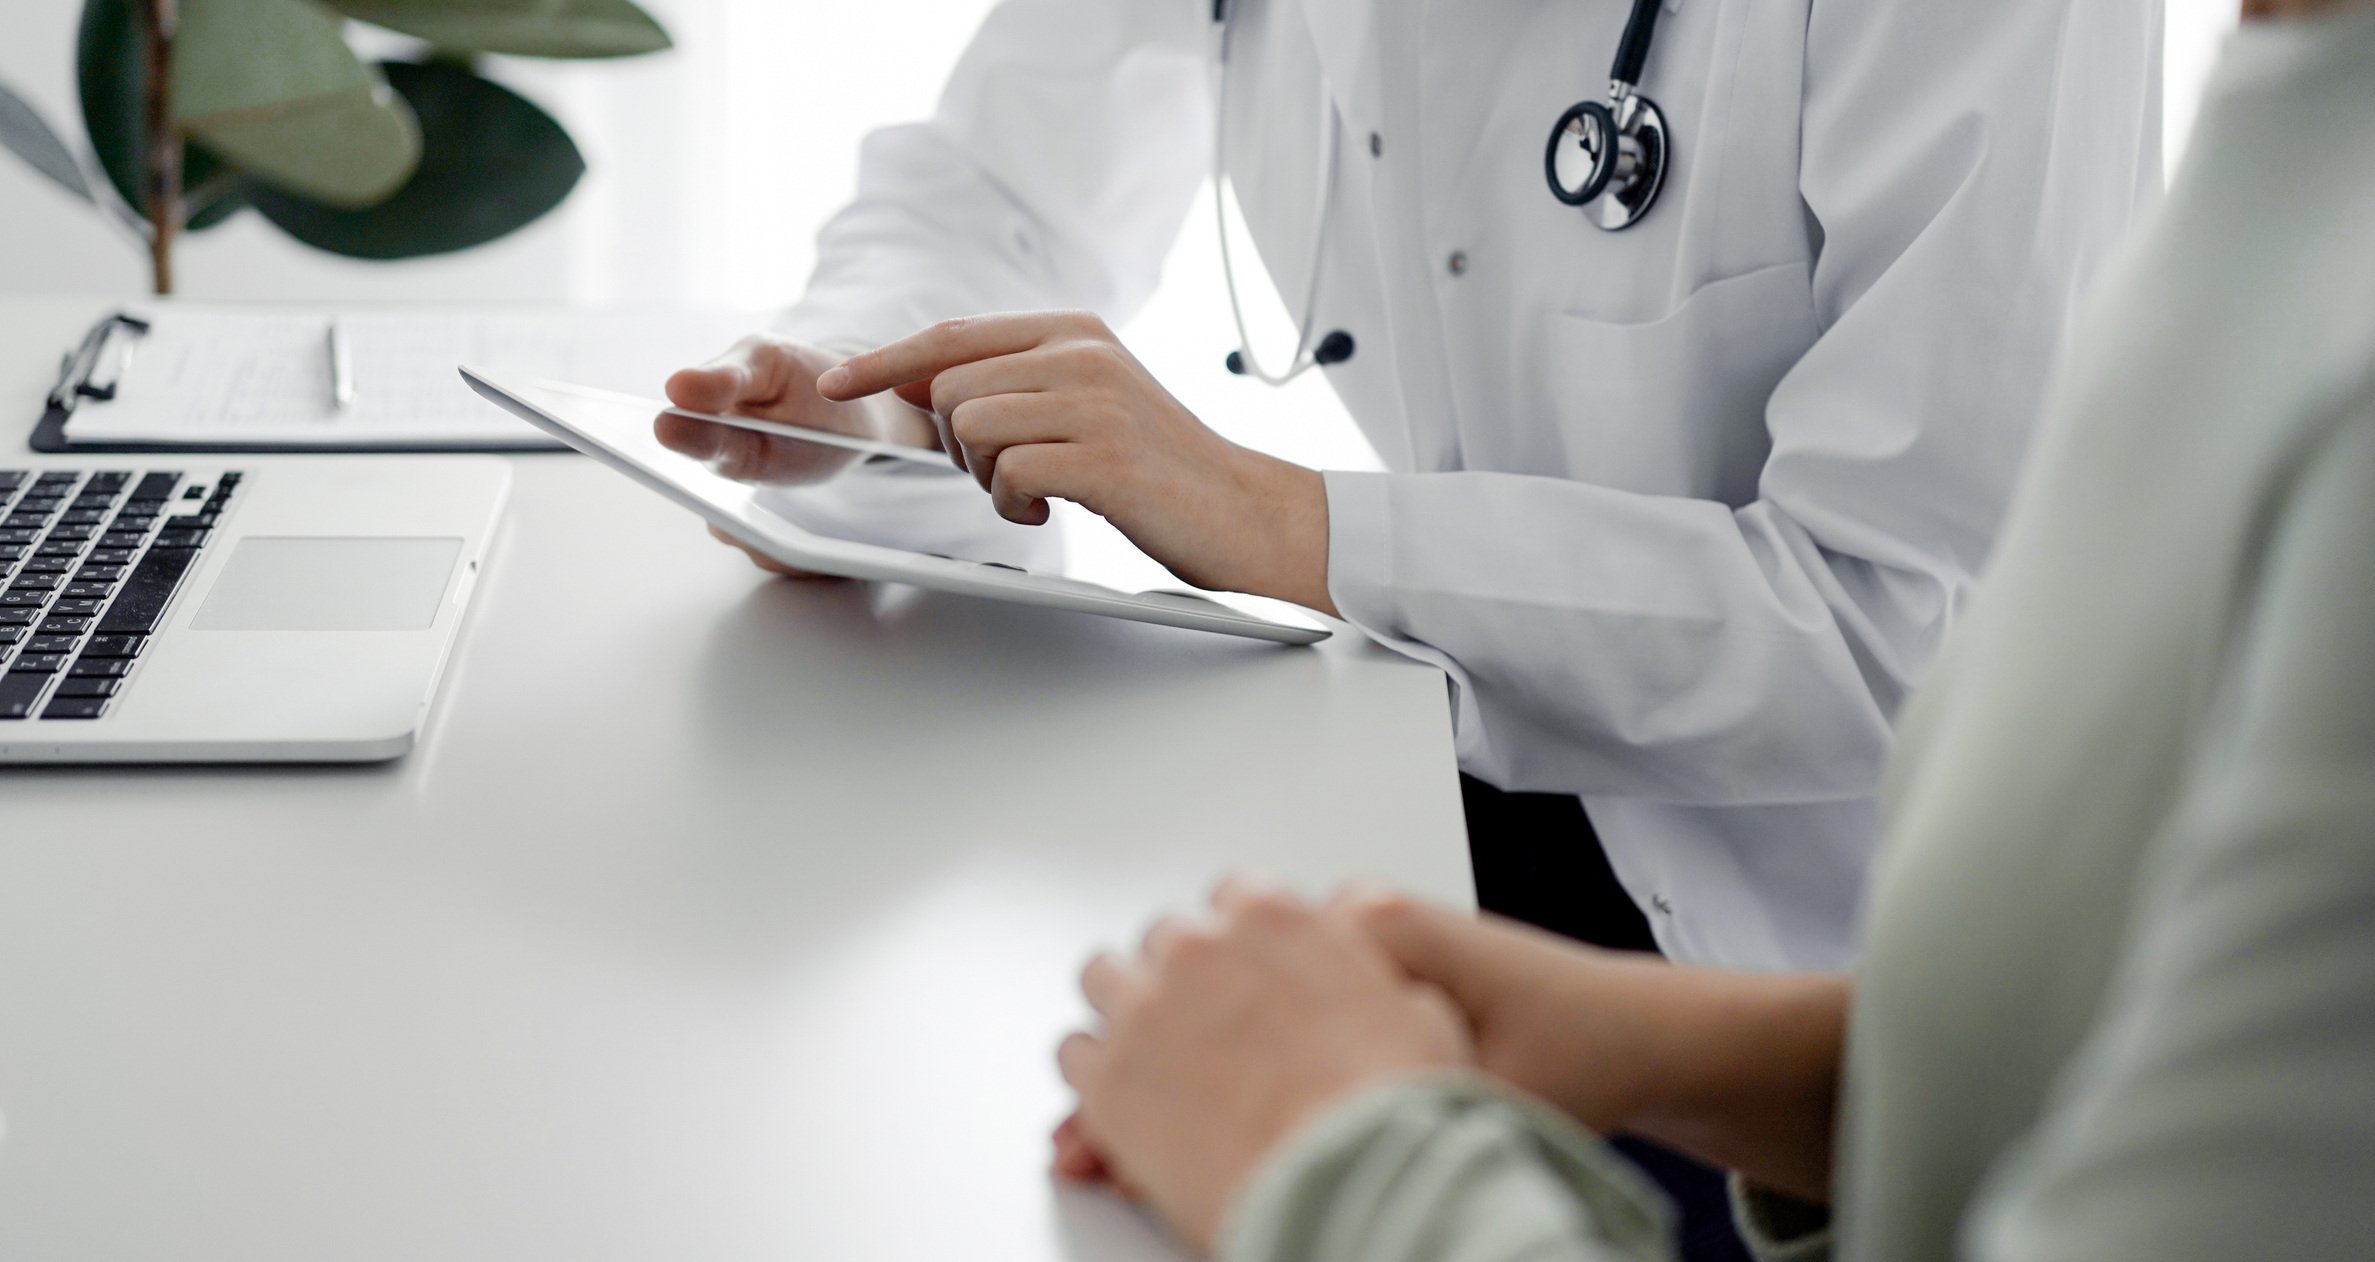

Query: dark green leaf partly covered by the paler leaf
[[249, 62, 587, 259]]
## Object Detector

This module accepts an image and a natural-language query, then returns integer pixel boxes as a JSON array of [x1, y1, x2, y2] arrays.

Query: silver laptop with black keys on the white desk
[[0, 456, 511, 763]]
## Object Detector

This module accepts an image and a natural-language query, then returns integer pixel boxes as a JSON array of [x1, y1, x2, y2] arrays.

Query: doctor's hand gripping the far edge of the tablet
[[653, 333, 938, 578]]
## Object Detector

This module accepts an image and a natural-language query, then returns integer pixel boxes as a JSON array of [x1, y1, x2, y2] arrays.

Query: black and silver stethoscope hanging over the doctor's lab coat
[[1211, 0, 1674, 385]]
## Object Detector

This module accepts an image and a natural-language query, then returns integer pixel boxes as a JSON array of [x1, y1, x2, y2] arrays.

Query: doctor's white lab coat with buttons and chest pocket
[[784, 0, 2161, 967]]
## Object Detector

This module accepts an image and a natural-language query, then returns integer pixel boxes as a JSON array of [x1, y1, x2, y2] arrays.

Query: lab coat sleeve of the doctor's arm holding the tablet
[[767, 0, 1211, 559]]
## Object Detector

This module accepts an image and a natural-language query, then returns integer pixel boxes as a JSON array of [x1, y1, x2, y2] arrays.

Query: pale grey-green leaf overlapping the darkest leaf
[[173, 0, 420, 207]]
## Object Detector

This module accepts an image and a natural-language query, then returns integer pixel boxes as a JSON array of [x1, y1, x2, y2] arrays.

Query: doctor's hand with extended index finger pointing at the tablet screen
[[817, 311, 1335, 613]]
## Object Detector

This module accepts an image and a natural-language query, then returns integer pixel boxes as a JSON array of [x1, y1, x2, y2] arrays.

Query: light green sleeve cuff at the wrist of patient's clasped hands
[[1218, 1074, 1674, 1262]]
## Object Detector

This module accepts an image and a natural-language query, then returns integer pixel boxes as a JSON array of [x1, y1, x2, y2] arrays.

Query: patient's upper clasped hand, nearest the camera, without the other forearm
[[1057, 882, 1470, 1250]]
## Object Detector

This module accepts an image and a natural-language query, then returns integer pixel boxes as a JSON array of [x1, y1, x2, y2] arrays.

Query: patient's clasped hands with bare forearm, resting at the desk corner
[[1055, 879, 1848, 1248]]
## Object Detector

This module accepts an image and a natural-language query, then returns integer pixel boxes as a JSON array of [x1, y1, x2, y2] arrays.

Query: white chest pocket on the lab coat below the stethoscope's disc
[[1532, 261, 1822, 506]]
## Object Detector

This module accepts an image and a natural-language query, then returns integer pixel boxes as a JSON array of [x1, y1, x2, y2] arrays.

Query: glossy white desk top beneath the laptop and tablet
[[0, 299, 1468, 1262]]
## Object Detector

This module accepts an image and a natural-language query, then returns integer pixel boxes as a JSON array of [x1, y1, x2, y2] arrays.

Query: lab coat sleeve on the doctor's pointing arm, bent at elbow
[[1328, 0, 2159, 806]]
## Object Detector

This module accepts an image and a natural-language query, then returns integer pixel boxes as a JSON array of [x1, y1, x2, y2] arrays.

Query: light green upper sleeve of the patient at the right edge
[[1964, 406, 2375, 1262]]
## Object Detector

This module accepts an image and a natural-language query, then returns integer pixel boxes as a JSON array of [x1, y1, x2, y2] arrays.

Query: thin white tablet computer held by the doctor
[[461, 366, 1330, 644]]
